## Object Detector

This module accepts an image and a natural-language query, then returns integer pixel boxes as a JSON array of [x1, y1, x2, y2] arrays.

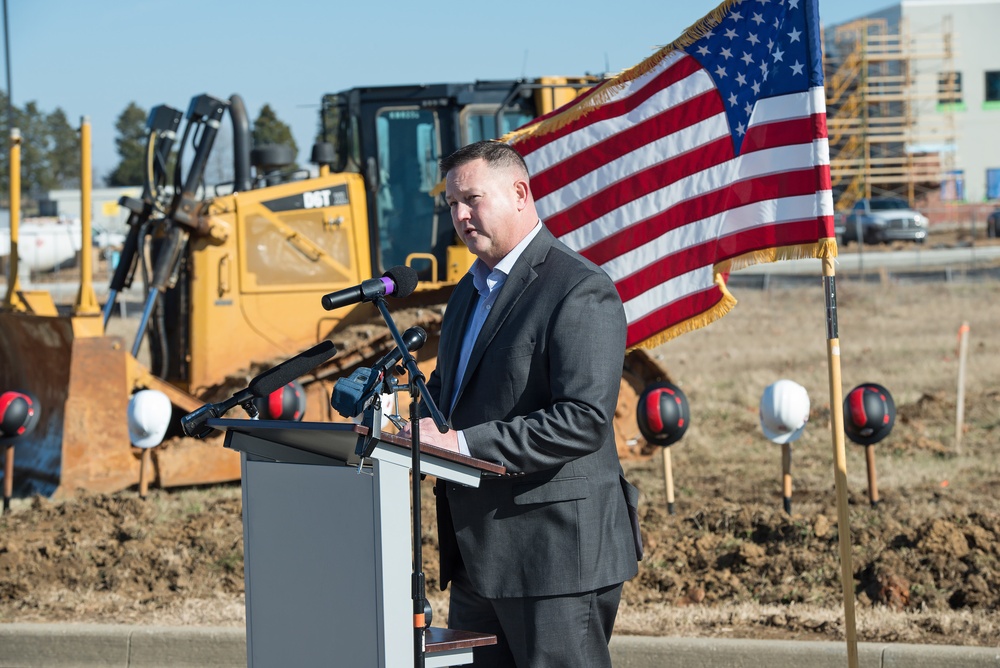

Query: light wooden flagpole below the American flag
[[823, 256, 858, 668]]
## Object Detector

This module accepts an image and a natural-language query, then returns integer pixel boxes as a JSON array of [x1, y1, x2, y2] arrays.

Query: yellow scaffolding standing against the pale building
[[824, 17, 961, 211]]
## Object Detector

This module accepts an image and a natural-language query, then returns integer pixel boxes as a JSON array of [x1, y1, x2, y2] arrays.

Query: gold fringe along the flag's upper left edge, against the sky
[[497, 0, 741, 144]]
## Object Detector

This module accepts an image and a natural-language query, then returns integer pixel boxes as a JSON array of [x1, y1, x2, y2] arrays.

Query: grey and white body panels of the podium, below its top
[[243, 456, 413, 667]]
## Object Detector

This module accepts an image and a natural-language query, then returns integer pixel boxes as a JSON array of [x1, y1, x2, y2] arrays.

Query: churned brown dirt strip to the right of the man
[[629, 486, 1000, 613]]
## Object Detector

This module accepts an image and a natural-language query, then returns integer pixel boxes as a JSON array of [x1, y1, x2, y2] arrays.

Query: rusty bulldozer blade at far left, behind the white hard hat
[[0, 313, 240, 497]]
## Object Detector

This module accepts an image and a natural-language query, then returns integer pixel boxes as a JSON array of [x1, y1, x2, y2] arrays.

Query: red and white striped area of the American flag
[[512, 51, 834, 346]]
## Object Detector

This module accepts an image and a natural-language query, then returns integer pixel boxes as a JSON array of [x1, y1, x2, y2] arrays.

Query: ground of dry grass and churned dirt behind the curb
[[0, 268, 1000, 647]]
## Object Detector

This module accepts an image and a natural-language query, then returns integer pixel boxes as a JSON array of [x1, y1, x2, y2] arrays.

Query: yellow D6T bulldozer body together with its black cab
[[165, 79, 592, 396]]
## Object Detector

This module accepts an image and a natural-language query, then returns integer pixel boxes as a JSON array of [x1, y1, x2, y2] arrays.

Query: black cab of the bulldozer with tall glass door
[[321, 77, 594, 282]]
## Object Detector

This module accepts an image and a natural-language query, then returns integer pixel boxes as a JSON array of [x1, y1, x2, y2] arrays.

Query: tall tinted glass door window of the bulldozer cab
[[375, 108, 441, 269]]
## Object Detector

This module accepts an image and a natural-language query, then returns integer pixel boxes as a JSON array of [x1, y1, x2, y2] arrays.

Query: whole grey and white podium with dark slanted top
[[213, 418, 504, 668]]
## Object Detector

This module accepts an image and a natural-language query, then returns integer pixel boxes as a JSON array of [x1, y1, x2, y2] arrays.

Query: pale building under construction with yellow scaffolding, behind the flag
[[824, 0, 1000, 210]]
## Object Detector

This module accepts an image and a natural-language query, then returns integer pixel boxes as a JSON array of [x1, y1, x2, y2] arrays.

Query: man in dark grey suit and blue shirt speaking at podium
[[402, 142, 638, 668]]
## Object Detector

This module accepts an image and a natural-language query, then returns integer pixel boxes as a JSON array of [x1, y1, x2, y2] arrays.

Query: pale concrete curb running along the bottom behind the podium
[[0, 624, 1000, 668]]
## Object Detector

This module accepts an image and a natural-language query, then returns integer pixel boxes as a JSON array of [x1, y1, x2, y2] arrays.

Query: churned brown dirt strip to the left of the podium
[[0, 486, 243, 621]]
